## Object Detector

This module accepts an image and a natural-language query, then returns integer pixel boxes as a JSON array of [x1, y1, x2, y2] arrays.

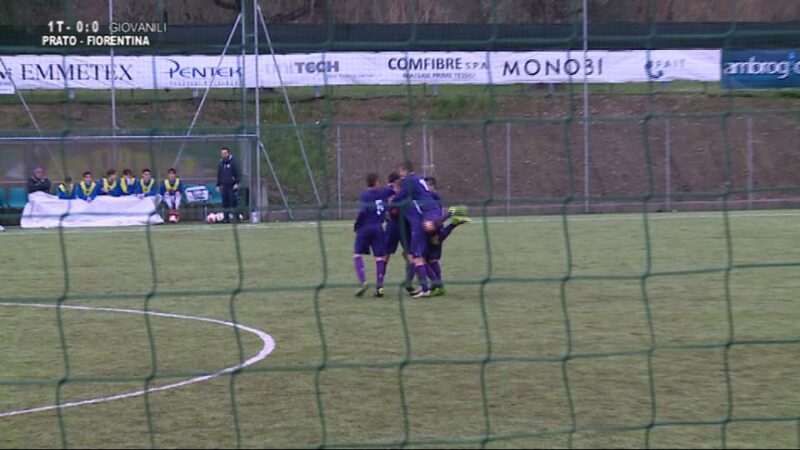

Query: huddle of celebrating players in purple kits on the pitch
[[353, 161, 471, 298]]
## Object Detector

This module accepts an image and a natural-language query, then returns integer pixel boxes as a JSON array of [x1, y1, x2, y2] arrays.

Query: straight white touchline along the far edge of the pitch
[[0, 211, 800, 239]]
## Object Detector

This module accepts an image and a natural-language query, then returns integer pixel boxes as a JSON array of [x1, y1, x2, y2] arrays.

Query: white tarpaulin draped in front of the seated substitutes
[[20, 192, 164, 228]]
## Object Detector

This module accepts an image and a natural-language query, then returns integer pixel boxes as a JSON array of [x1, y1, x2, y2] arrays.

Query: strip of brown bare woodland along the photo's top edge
[[0, 0, 800, 25]]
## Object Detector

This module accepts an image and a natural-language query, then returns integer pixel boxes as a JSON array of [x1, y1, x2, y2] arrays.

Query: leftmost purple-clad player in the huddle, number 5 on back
[[353, 173, 394, 297]]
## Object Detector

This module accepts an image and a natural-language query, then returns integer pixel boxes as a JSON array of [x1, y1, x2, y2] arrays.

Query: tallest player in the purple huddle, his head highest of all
[[393, 161, 437, 298]]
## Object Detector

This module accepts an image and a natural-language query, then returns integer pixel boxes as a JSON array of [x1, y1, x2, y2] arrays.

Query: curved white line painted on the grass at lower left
[[0, 303, 275, 418]]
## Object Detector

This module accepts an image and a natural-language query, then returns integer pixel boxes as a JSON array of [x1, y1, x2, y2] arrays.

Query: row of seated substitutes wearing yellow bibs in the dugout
[[56, 169, 185, 220]]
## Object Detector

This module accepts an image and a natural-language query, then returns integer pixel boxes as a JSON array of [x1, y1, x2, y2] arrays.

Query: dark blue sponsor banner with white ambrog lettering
[[722, 49, 800, 89]]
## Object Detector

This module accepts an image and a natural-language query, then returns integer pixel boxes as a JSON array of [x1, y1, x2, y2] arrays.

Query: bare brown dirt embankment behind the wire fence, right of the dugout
[[328, 95, 800, 211]]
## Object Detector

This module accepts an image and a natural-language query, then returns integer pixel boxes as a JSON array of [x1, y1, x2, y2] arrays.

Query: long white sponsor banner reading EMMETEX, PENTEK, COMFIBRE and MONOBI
[[0, 50, 721, 89]]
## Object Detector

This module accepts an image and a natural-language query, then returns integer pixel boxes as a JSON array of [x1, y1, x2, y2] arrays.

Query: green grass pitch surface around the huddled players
[[0, 211, 800, 448]]
